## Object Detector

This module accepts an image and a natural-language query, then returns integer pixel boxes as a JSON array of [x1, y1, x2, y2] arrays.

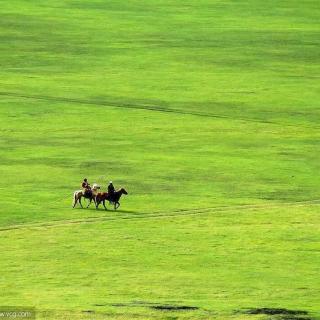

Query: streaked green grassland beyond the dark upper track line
[[1, 1, 320, 126]]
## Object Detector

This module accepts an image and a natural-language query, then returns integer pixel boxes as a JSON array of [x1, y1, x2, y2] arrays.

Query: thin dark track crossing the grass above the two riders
[[0, 91, 316, 128]]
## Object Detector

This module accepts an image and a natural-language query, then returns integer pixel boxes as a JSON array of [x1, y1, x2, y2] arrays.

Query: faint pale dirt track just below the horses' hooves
[[0, 200, 320, 232]]
